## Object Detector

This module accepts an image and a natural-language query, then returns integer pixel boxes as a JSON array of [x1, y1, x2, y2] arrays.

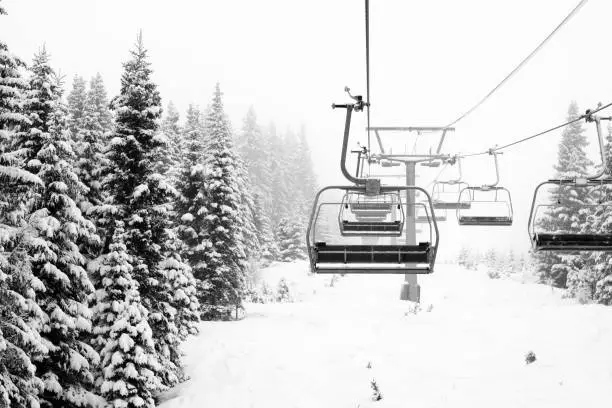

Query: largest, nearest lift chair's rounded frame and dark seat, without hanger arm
[[306, 186, 439, 274]]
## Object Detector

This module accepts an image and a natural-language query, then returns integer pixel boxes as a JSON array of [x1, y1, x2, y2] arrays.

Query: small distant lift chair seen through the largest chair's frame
[[338, 191, 404, 236]]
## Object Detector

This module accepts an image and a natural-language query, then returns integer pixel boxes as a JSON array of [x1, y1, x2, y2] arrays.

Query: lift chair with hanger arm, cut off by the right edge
[[528, 111, 612, 252]]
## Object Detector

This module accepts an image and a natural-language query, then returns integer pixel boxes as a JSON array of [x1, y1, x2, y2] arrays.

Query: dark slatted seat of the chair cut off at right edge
[[533, 233, 612, 251]]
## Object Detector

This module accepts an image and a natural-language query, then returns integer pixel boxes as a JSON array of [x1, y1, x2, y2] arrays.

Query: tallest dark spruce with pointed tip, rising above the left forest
[[96, 35, 193, 386]]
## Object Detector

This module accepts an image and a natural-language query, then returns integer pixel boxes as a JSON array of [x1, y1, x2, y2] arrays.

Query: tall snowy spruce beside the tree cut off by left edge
[[19, 49, 100, 407]]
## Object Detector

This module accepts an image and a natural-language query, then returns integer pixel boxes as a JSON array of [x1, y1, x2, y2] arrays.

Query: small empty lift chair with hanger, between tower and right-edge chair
[[457, 149, 514, 227]]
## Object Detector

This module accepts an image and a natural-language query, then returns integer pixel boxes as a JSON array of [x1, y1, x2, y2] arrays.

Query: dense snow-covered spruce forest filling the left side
[[0, 3, 316, 408]]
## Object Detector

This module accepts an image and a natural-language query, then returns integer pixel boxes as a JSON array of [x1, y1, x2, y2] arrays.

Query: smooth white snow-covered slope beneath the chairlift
[[161, 263, 612, 408]]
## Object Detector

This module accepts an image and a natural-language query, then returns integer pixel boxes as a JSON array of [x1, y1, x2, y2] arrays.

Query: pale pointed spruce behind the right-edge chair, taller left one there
[[534, 102, 592, 288]]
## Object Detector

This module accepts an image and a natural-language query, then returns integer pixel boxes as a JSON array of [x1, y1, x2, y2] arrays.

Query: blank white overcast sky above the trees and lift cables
[[0, 0, 612, 255]]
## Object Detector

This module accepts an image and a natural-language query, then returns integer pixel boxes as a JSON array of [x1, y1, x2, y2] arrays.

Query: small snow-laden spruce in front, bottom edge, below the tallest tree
[[91, 221, 161, 408]]
